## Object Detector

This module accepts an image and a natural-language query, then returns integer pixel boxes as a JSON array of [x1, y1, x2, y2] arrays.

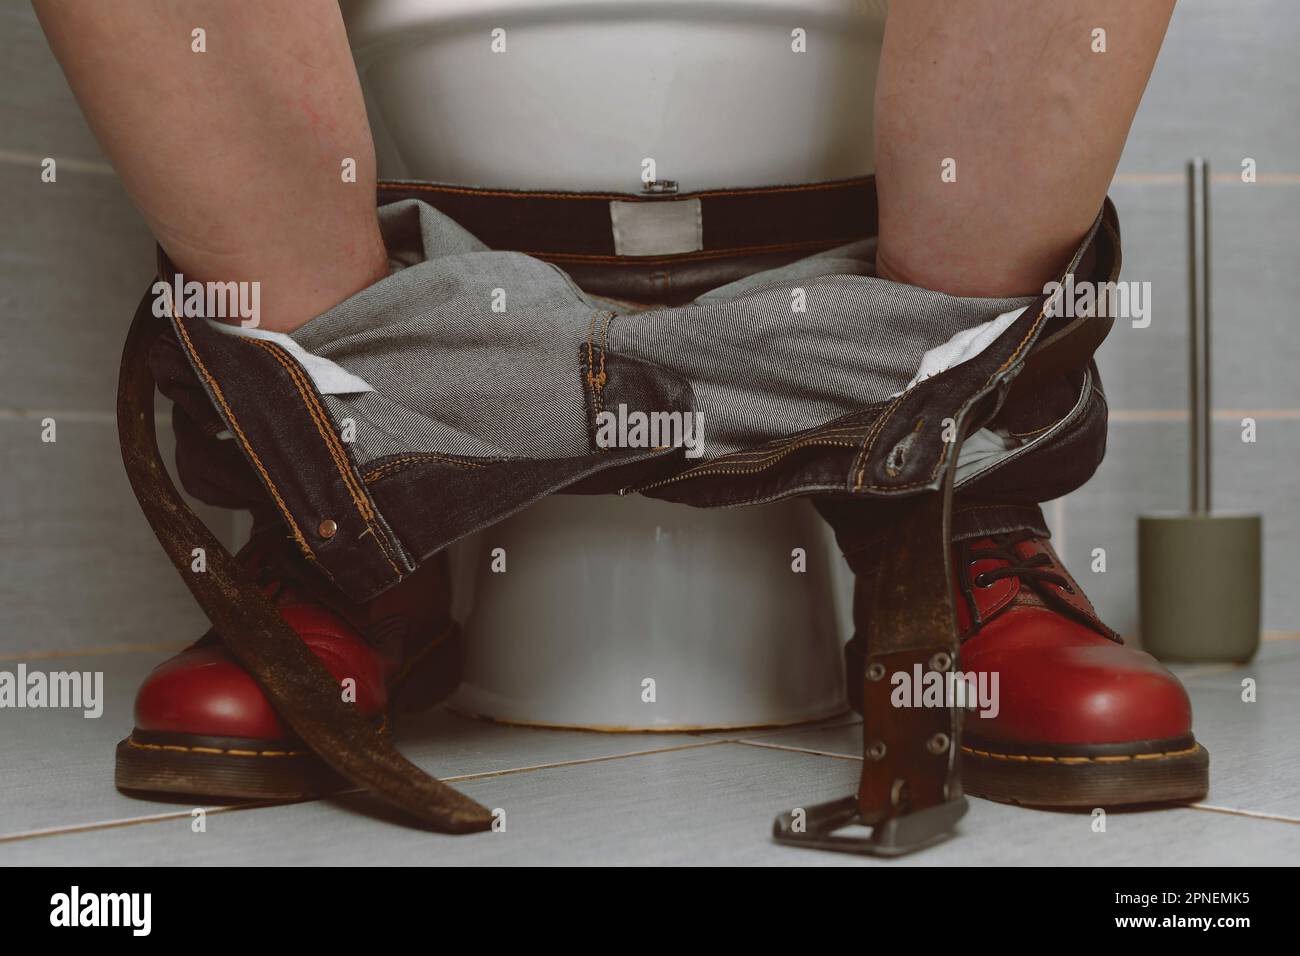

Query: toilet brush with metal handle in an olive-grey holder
[[1138, 159, 1261, 661]]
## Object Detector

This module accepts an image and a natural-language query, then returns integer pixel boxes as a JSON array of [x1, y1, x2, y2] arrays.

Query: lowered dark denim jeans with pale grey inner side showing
[[149, 175, 1119, 600]]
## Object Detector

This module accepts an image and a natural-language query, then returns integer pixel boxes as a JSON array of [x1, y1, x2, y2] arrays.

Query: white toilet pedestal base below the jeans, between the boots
[[452, 496, 848, 730]]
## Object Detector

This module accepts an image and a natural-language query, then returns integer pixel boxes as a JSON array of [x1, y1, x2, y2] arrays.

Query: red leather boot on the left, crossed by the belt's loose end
[[117, 532, 462, 800]]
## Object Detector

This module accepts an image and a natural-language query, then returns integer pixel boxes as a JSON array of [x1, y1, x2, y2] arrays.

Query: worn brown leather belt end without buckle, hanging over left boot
[[117, 293, 491, 832]]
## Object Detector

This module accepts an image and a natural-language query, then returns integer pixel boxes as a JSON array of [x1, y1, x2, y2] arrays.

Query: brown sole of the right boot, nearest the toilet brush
[[962, 736, 1210, 809]]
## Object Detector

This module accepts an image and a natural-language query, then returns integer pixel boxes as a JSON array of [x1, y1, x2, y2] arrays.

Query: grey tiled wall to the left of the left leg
[[0, 0, 231, 661]]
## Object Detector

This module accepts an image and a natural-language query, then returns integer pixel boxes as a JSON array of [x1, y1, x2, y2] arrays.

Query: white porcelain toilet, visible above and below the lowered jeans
[[341, 0, 885, 732]]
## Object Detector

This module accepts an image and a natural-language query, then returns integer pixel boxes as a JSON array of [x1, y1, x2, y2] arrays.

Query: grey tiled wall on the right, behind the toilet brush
[[1047, 0, 1300, 635]]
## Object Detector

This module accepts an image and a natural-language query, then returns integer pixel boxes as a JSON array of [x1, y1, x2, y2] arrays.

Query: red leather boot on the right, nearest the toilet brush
[[845, 531, 1209, 808]]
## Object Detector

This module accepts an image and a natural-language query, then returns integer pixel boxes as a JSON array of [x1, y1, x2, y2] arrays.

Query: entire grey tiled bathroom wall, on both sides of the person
[[0, 0, 1300, 659]]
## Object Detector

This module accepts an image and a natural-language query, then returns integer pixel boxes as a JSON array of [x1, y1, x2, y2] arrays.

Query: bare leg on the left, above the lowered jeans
[[34, 0, 387, 330]]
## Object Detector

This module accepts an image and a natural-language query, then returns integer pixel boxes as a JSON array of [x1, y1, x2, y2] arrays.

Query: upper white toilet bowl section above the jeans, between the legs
[[341, 0, 885, 191]]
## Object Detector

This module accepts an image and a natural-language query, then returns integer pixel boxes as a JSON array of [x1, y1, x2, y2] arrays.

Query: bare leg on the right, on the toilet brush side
[[875, 0, 1174, 295]]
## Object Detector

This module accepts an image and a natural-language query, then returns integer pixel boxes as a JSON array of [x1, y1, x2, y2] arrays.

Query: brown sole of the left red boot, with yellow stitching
[[114, 730, 350, 800]]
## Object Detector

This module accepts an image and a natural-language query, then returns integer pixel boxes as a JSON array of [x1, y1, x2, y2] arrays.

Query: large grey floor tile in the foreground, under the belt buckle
[[0, 743, 1300, 866]]
